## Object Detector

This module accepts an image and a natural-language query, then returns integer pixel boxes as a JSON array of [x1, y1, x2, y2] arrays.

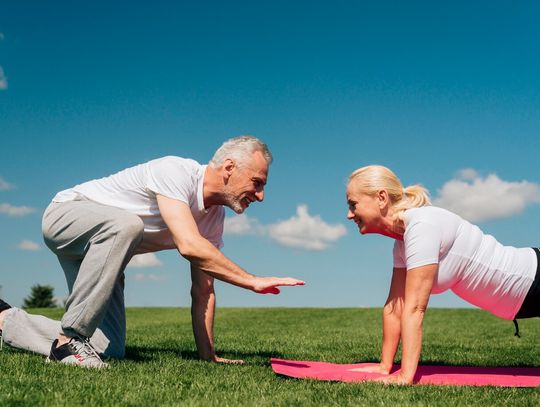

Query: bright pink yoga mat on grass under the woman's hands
[[271, 359, 540, 387]]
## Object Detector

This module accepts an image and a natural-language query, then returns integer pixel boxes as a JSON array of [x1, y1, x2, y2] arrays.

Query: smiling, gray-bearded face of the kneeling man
[[221, 151, 268, 214]]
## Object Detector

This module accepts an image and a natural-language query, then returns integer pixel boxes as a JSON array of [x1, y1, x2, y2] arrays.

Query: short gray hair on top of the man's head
[[208, 136, 273, 167]]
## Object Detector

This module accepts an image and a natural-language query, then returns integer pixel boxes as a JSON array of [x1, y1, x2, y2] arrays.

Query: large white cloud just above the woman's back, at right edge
[[433, 169, 540, 222]]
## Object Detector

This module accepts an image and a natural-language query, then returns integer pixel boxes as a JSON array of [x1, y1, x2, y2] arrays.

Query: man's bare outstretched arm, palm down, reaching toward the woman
[[157, 195, 304, 294]]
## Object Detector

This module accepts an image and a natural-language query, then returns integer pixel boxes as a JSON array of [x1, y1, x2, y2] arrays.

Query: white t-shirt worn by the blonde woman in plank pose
[[394, 206, 537, 319]]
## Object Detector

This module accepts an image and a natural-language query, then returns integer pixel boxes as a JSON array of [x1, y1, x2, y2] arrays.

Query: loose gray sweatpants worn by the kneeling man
[[2, 198, 143, 358]]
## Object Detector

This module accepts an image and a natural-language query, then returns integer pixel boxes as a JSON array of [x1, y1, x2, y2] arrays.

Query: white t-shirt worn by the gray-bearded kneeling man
[[53, 156, 225, 253]]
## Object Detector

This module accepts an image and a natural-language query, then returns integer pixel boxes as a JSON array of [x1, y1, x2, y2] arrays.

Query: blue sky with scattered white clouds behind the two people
[[0, 0, 540, 307]]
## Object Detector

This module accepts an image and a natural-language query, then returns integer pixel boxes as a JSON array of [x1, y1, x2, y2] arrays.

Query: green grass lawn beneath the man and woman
[[0, 308, 540, 406]]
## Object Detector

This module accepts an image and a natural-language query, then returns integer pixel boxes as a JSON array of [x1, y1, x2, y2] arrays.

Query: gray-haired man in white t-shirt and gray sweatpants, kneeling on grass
[[0, 136, 304, 368]]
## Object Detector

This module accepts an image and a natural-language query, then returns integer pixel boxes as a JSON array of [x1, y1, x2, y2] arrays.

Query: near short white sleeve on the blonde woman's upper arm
[[403, 221, 441, 270]]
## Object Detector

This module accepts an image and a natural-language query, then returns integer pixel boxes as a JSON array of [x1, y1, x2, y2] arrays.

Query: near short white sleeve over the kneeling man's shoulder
[[147, 157, 197, 205]]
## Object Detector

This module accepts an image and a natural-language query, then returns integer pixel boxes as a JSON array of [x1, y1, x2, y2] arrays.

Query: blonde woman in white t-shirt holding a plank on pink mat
[[347, 165, 540, 384]]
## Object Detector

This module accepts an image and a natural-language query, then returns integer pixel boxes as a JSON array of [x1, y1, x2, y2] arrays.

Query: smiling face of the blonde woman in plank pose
[[347, 183, 383, 235]]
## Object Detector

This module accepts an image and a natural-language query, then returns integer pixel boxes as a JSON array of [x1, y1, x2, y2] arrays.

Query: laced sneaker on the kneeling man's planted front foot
[[47, 337, 109, 369]]
